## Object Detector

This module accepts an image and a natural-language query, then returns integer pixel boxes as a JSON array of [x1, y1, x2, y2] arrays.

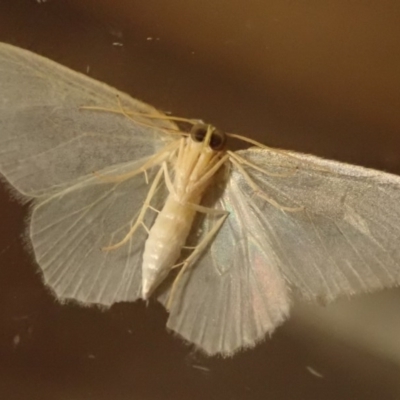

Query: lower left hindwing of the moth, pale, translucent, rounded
[[30, 160, 166, 306]]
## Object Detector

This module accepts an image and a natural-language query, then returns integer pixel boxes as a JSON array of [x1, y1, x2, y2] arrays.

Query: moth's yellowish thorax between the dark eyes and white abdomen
[[174, 136, 223, 202]]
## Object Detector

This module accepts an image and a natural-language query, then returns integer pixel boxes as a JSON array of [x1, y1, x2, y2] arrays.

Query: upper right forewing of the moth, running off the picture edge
[[233, 149, 400, 301]]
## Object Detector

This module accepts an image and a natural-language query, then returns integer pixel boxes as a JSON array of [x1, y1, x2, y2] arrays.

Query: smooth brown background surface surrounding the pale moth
[[0, 0, 400, 400]]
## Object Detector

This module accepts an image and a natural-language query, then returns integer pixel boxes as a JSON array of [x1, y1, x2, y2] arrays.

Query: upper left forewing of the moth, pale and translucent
[[0, 44, 176, 197]]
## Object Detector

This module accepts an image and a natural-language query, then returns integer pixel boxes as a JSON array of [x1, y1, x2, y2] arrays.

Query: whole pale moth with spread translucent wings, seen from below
[[0, 44, 400, 356]]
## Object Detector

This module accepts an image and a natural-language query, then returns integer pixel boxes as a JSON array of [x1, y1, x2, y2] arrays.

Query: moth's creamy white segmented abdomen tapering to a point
[[142, 196, 195, 299]]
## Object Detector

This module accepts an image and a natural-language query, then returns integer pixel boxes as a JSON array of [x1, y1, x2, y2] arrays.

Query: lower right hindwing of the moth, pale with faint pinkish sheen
[[161, 169, 289, 356]]
